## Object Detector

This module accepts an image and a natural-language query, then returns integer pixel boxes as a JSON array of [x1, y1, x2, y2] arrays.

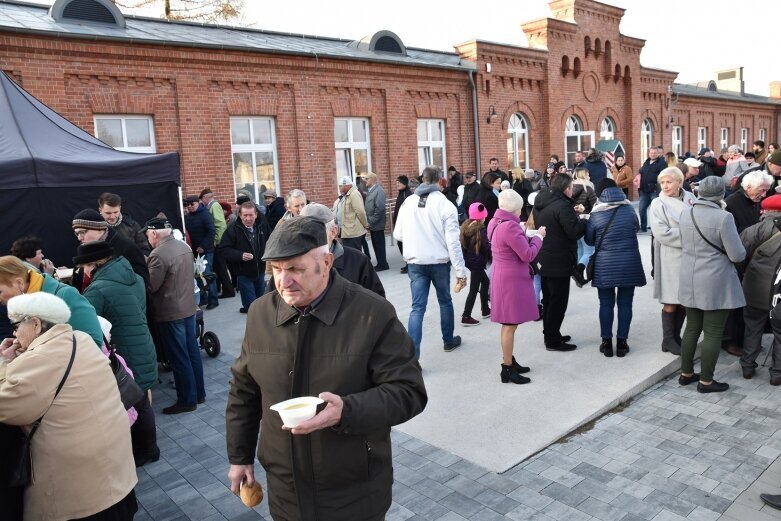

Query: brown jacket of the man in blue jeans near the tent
[[147, 235, 195, 322]]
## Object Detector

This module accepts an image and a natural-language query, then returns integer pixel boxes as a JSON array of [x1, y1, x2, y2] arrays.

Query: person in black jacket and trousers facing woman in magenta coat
[[532, 174, 586, 351]]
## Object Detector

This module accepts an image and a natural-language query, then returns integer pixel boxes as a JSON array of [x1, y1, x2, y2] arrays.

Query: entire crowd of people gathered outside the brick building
[[0, 137, 781, 520]]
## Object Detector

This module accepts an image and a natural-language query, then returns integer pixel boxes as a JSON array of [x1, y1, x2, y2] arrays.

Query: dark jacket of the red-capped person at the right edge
[[736, 212, 781, 310]]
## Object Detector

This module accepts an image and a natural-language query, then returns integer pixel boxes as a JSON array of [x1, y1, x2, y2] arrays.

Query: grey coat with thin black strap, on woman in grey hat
[[678, 200, 746, 311]]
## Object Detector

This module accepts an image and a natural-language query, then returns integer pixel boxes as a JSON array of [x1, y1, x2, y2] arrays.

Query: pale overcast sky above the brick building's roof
[[32, 0, 781, 96]]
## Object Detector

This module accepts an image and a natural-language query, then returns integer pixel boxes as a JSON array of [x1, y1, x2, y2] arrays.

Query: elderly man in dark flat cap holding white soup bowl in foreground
[[225, 217, 427, 521]]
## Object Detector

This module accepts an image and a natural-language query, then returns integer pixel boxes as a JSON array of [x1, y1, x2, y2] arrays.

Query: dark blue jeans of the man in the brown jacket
[[157, 315, 206, 405]]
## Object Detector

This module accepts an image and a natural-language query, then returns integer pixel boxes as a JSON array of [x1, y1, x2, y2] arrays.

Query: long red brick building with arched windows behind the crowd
[[0, 0, 781, 204]]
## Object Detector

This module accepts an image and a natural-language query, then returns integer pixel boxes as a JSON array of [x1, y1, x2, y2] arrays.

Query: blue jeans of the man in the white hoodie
[[407, 264, 455, 359]]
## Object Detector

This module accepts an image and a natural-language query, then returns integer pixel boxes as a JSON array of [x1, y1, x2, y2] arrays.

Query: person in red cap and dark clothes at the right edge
[[740, 195, 781, 385]]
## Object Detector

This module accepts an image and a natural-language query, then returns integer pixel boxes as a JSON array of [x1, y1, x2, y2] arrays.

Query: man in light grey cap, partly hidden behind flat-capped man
[[301, 203, 385, 297]]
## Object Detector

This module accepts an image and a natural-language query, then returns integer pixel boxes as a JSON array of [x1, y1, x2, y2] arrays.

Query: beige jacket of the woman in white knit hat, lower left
[[0, 324, 138, 521]]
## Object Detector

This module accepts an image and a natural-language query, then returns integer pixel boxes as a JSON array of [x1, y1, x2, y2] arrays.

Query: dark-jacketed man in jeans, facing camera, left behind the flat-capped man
[[220, 201, 270, 313]]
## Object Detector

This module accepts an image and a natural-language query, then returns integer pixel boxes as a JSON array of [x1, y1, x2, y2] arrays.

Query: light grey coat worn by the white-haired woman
[[648, 190, 695, 304]]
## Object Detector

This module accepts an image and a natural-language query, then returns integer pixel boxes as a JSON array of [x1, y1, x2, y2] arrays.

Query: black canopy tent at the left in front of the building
[[0, 71, 182, 266]]
